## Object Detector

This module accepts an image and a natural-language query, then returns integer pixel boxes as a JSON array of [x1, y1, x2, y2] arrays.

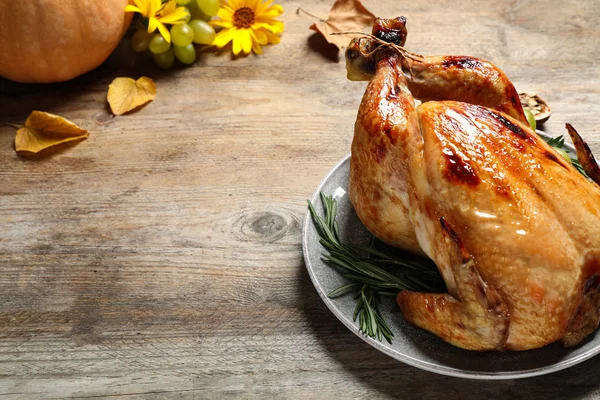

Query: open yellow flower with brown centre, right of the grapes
[[210, 0, 283, 55]]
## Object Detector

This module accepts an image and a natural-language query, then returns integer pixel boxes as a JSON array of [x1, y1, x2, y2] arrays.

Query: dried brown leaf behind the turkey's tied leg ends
[[310, 0, 375, 49]]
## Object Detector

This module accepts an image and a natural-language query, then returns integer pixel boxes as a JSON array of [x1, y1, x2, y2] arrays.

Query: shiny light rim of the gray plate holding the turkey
[[302, 130, 600, 381]]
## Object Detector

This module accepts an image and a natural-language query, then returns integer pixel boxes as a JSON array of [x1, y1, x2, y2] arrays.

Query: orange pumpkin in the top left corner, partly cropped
[[0, 0, 132, 83]]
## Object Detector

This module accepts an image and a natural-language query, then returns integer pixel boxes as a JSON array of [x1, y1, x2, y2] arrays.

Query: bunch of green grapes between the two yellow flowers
[[131, 0, 220, 69]]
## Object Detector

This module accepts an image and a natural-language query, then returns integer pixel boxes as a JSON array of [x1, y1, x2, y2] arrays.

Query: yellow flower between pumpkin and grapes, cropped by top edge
[[125, 0, 187, 43]]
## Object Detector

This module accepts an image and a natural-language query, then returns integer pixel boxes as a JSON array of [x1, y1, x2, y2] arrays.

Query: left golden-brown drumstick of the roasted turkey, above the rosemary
[[348, 52, 422, 254]]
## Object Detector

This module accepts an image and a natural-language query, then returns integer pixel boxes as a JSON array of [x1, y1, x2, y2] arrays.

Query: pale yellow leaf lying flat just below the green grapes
[[106, 76, 156, 115]]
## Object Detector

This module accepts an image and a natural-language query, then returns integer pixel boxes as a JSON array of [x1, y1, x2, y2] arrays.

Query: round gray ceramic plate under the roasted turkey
[[303, 132, 600, 379]]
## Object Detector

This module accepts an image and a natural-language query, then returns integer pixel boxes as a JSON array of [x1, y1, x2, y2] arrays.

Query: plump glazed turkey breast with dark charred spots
[[418, 102, 600, 350]]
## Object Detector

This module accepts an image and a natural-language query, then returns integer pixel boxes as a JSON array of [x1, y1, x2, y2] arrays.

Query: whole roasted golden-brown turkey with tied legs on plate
[[346, 17, 600, 350]]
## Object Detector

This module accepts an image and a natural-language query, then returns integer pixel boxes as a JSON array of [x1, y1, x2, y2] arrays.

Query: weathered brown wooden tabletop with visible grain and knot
[[0, 0, 600, 400]]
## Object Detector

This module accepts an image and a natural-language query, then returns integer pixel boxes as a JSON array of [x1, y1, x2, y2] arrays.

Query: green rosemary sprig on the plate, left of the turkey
[[308, 193, 446, 343]]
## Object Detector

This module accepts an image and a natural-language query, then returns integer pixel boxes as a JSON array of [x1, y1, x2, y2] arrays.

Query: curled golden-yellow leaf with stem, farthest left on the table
[[15, 111, 88, 154]]
